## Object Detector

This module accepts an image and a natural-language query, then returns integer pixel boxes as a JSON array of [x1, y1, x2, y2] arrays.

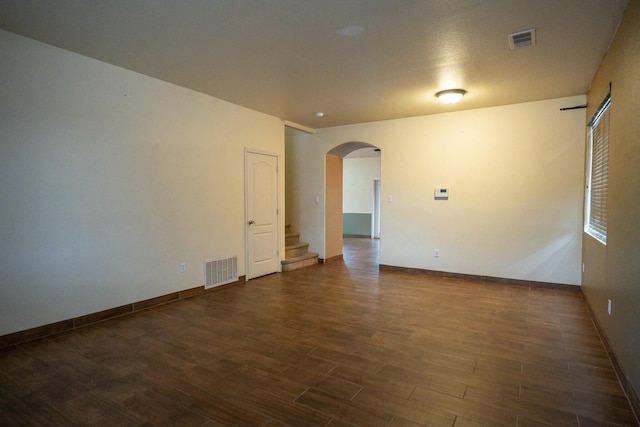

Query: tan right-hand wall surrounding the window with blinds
[[582, 0, 640, 404]]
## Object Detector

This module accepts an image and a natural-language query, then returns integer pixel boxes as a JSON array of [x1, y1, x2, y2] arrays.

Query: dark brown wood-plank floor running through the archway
[[0, 239, 635, 427]]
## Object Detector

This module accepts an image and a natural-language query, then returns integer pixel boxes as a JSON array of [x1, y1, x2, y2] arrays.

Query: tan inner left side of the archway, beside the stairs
[[325, 154, 342, 259]]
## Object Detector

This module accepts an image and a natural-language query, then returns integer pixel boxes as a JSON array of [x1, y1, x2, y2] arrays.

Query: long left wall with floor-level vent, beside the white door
[[0, 31, 284, 335]]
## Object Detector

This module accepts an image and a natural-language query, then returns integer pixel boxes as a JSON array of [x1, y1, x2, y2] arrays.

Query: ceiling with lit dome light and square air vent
[[0, 0, 629, 128]]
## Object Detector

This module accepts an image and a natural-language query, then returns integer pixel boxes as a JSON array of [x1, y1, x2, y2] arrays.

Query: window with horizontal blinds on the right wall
[[584, 96, 611, 245]]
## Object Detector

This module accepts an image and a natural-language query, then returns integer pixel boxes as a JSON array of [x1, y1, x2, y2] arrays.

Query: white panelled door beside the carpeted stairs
[[245, 151, 280, 279]]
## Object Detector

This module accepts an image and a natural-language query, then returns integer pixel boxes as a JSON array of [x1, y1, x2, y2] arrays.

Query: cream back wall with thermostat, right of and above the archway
[[309, 96, 585, 285]]
